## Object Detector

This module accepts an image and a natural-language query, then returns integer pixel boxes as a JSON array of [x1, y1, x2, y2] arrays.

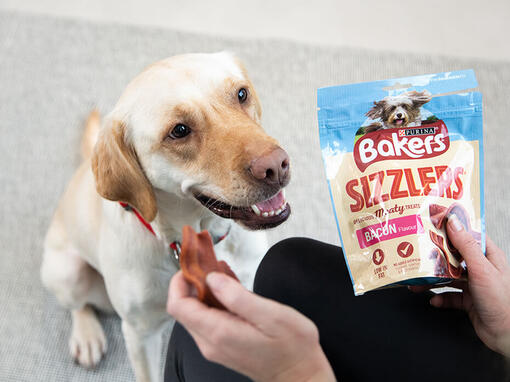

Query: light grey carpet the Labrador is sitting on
[[0, 8, 510, 382]]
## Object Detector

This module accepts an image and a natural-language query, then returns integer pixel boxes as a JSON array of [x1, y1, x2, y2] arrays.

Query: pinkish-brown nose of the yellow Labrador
[[250, 148, 290, 186]]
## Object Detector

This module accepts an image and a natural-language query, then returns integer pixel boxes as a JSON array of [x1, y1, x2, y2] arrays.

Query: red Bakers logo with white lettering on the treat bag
[[353, 120, 450, 172]]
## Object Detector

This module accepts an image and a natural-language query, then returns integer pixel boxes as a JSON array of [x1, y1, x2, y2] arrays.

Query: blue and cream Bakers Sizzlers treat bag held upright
[[317, 70, 485, 295]]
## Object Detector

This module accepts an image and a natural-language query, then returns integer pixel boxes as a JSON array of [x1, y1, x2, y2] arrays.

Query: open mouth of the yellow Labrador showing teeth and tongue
[[195, 190, 290, 229]]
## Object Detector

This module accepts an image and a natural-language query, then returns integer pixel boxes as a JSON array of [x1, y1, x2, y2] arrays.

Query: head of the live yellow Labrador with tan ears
[[92, 52, 290, 229]]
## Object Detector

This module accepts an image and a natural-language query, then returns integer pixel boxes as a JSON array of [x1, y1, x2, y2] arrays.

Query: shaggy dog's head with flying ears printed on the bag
[[366, 90, 431, 129]]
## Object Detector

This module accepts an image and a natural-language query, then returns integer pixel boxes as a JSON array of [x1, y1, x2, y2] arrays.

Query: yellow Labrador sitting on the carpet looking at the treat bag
[[41, 52, 290, 381]]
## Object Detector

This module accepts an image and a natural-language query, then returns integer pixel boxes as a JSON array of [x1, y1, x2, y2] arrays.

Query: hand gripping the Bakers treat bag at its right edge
[[410, 215, 510, 357]]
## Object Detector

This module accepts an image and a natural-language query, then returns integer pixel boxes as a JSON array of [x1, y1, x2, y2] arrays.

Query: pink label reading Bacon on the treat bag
[[356, 215, 425, 248]]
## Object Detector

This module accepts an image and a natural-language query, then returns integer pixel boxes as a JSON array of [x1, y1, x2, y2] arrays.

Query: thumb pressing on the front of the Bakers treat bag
[[446, 214, 491, 274]]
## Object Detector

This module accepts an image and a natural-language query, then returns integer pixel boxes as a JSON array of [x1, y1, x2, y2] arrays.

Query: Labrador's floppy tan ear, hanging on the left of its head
[[92, 121, 157, 222]]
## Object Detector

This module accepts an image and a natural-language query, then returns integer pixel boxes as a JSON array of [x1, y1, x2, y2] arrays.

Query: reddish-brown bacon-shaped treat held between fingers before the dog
[[179, 226, 239, 309]]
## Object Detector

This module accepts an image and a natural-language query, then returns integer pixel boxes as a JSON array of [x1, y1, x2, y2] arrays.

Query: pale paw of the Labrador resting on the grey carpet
[[69, 308, 106, 368]]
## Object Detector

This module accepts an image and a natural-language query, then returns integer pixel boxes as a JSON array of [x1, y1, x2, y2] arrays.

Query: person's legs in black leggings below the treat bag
[[165, 238, 510, 382]]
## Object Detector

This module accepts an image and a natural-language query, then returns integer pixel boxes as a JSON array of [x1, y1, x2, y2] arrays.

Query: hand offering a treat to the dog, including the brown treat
[[167, 227, 335, 382]]
